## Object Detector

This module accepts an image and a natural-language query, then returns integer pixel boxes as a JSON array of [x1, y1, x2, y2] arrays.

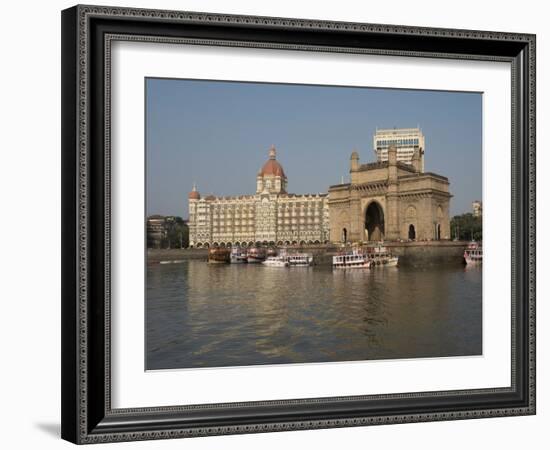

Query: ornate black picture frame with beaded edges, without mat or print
[[62, 6, 535, 444]]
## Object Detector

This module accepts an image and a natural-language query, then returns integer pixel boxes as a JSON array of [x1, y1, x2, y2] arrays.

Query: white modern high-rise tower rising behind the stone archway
[[373, 128, 426, 172]]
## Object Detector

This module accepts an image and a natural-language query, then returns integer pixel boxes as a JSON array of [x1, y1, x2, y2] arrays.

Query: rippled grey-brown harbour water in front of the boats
[[146, 261, 482, 369]]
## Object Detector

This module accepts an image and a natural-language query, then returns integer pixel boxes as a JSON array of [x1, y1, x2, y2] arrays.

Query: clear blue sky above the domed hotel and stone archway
[[146, 79, 482, 218]]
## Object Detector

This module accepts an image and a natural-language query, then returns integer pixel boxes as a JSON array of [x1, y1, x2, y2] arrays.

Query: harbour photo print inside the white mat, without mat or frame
[[144, 78, 483, 370]]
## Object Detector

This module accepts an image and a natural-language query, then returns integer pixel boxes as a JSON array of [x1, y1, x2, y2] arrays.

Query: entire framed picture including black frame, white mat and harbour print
[[62, 6, 535, 444]]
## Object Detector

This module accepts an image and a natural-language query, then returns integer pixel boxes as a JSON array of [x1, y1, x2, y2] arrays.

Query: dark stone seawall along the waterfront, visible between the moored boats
[[147, 241, 468, 267]]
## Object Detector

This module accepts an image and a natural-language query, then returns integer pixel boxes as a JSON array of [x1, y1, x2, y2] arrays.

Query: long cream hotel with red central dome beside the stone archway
[[189, 147, 329, 247]]
